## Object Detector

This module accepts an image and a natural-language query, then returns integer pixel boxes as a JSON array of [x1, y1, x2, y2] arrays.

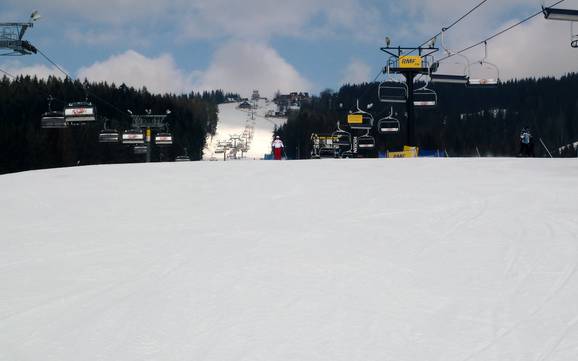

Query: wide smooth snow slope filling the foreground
[[0, 159, 578, 361]]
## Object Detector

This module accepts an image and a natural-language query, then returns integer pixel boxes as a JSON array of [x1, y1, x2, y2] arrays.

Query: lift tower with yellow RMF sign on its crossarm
[[380, 37, 439, 147]]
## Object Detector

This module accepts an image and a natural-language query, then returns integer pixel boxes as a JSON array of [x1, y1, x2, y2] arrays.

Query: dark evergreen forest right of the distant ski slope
[[276, 73, 578, 159]]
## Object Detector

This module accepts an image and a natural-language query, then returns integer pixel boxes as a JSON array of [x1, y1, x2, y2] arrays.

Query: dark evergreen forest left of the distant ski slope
[[0, 76, 236, 174]]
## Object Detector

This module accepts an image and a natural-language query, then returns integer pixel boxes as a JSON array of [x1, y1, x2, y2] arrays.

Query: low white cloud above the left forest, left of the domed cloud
[[78, 50, 193, 93]]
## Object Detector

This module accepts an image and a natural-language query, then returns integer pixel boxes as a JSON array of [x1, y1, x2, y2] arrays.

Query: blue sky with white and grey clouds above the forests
[[0, 0, 578, 95]]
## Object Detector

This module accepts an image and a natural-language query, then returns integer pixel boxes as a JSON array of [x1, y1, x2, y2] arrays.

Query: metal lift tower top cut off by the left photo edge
[[0, 11, 40, 56]]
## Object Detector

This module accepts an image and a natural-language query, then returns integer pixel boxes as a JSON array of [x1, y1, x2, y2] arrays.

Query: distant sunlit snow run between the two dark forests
[[203, 99, 287, 160]]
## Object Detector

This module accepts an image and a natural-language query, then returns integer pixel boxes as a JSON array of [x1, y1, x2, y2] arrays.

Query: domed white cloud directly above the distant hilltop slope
[[197, 41, 312, 96]]
